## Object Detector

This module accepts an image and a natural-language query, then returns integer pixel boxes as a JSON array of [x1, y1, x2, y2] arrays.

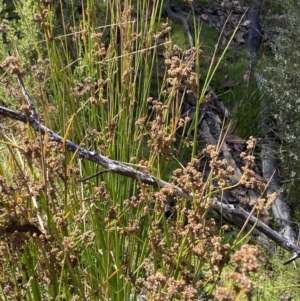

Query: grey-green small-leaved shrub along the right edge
[[264, 0, 300, 202]]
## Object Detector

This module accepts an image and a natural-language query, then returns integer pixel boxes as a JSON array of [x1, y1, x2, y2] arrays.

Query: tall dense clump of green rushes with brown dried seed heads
[[0, 0, 296, 301]]
